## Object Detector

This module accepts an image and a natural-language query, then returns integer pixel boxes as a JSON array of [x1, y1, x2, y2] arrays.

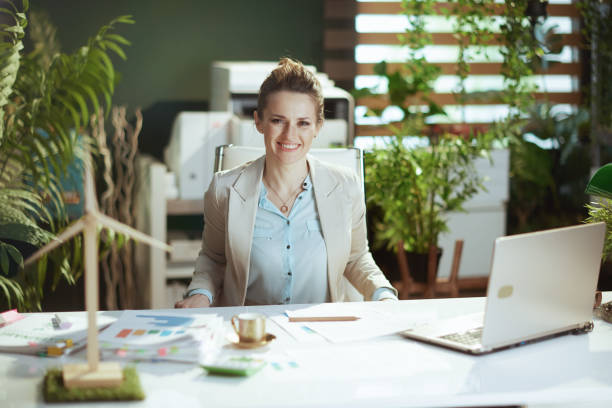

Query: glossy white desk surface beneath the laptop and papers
[[0, 292, 612, 408]]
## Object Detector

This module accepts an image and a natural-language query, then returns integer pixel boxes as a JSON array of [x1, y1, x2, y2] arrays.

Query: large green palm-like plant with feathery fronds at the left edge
[[0, 0, 132, 309]]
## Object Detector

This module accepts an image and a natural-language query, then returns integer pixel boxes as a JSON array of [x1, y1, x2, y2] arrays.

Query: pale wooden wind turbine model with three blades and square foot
[[25, 153, 172, 388]]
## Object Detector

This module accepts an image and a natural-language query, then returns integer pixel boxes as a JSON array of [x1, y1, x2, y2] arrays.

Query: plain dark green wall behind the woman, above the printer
[[31, 0, 323, 109]]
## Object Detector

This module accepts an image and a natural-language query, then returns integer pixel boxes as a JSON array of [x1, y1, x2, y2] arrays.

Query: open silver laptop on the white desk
[[401, 223, 606, 354]]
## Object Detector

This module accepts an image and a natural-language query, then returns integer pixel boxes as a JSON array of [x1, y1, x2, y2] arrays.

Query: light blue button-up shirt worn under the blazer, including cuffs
[[188, 175, 395, 304]]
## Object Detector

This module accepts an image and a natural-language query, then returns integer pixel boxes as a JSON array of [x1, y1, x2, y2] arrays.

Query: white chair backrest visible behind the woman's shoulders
[[215, 145, 364, 302]]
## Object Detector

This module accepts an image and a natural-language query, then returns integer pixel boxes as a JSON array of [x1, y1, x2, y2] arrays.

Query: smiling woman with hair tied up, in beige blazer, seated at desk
[[176, 58, 397, 307]]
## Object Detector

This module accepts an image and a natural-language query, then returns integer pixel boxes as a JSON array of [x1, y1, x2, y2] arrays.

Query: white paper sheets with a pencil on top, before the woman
[[273, 303, 433, 343]]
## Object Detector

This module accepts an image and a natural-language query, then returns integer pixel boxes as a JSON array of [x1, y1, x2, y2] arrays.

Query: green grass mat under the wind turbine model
[[43, 367, 145, 402]]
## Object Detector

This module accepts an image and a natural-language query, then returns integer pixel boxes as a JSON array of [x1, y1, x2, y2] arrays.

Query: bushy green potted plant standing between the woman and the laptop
[[365, 113, 489, 282]]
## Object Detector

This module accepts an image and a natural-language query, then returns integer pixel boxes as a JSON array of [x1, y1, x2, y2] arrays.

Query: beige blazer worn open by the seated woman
[[187, 155, 397, 306]]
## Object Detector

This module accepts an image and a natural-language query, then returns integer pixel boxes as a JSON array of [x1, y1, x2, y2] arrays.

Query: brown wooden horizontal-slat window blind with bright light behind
[[324, 0, 582, 143]]
